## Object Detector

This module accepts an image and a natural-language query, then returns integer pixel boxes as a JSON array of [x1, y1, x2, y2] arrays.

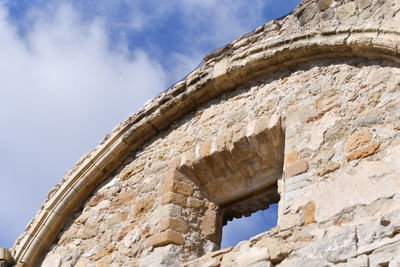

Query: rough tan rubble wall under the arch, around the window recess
[[42, 59, 400, 266]]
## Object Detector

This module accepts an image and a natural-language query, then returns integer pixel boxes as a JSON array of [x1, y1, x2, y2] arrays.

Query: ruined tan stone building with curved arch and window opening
[[0, 0, 400, 267]]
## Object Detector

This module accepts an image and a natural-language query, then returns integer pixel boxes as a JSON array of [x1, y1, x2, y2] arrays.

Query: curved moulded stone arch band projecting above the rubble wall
[[12, 20, 400, 266]]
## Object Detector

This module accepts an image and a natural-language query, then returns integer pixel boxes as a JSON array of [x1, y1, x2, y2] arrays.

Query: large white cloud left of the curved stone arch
[[0, 2, 166, 247]]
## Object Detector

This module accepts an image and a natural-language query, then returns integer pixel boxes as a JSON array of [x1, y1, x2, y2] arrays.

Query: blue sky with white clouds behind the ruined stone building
[[0, 0, 300, 248]]
